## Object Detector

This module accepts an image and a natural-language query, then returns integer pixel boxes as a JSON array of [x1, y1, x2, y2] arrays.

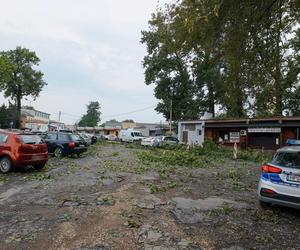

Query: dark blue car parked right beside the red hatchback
[[43, 132, 87, 158]]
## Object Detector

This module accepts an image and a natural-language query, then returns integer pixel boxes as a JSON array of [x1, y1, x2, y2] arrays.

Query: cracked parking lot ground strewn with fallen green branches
[[0, 143, 300, 249]]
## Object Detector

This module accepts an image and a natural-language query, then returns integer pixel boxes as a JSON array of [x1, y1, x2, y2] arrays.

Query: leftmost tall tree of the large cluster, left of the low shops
[[142, 11, 200, 120]]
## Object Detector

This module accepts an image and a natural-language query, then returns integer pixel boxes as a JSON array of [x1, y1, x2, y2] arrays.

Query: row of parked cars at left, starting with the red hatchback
[[0, 130, 97, 173]]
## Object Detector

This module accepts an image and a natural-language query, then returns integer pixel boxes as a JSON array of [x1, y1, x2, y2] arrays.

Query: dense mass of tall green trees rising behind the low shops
[[141, 0, 300, 120]]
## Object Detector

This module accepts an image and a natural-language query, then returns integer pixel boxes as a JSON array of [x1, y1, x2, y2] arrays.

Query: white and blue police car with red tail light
[[258, 146, 300, 209]]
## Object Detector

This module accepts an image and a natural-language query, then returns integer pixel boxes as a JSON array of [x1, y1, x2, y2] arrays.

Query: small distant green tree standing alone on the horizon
[[78, 101, 101, 127]]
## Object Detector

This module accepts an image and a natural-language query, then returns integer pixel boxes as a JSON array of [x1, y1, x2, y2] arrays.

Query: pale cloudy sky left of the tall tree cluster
[[0, 0, 170, 123]]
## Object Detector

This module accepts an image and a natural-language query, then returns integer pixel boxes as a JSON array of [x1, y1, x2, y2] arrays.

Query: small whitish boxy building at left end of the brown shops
[[178, 120, 205, 145]]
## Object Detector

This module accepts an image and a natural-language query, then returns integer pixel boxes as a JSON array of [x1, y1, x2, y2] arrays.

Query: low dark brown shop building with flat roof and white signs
[[205, 117, 300, 149]]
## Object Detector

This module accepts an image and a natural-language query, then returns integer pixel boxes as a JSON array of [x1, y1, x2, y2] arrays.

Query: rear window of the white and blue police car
[[272, 152, 300, 169]]
